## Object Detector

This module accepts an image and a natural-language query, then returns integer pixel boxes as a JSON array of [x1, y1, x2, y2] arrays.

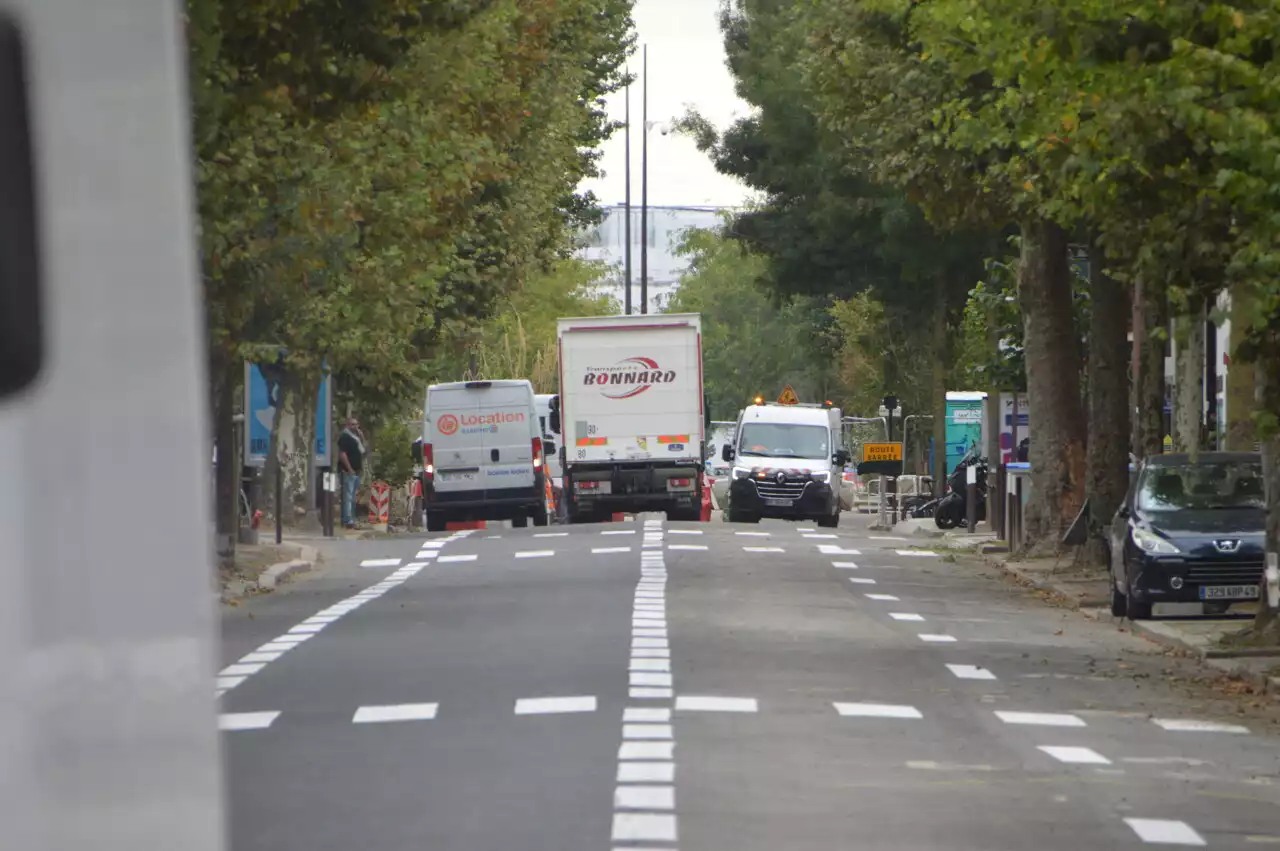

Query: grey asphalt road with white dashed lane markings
[[219, 516, 1280, 851]]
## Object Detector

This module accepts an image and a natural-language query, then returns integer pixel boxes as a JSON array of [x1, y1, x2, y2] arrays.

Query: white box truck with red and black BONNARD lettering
[[553, 314, 710, 523]]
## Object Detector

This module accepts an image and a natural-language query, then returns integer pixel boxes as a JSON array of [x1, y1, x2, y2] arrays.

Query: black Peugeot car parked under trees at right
[[1111, 452, 1266, 619]]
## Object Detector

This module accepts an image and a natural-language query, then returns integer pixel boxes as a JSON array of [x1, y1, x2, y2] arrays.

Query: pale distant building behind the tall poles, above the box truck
[[579, 203, 733, 314]]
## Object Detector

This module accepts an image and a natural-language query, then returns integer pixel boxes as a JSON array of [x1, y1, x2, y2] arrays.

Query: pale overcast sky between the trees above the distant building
[[582, 0, 749, 206]]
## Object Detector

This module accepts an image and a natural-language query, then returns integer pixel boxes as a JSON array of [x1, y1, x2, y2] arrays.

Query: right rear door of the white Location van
[[476, 381, 540, 490]]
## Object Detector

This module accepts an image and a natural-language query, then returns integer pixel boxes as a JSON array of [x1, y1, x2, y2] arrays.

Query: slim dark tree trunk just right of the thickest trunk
[[1084, 239, 1130, 567]]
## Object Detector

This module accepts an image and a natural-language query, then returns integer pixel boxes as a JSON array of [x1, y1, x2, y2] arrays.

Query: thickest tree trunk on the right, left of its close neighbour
[[1018, 221, 1085, 552]]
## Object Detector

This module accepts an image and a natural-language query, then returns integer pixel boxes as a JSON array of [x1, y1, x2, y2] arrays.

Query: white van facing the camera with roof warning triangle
[[721, 402, 849, 526]]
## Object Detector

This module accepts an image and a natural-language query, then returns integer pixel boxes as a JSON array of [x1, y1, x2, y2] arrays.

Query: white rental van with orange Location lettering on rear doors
[[422, 380, 549, 532]]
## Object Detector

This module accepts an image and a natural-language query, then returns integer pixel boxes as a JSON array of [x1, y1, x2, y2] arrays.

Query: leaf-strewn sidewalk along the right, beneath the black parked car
[[870, 520, 1280, 697]]
